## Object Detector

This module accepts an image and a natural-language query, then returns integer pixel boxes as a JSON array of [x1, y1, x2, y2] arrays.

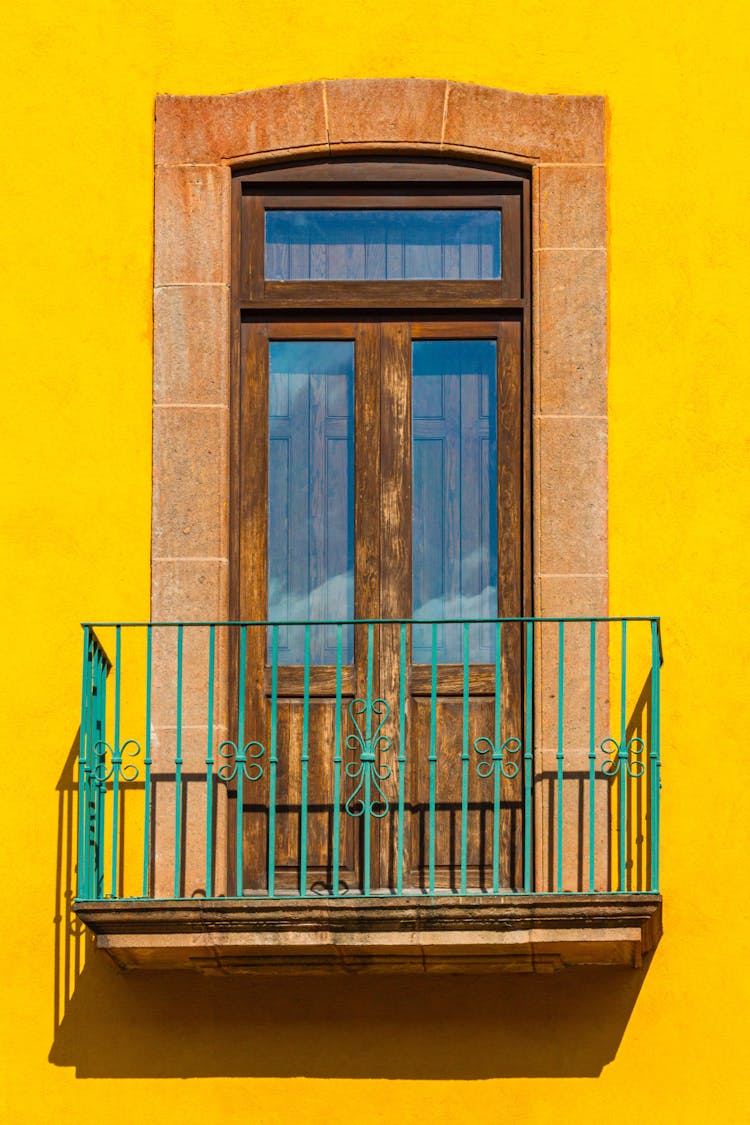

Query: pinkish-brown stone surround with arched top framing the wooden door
[[151, 79, 608, 891]]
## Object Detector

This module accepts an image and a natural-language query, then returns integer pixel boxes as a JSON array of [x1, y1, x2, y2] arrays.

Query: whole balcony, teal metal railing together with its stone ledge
[[75, 618, 661, 972]]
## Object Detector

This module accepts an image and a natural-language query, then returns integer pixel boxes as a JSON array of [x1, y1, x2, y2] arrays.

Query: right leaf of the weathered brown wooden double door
[[380, 322, 523, 892]]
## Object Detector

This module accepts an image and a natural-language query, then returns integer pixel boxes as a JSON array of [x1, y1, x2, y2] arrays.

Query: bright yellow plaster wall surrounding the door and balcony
[[0, 0, 750, 1123]]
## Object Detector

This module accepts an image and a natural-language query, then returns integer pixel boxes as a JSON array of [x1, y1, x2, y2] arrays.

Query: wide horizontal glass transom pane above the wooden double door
[[265, 209, 501, 281]]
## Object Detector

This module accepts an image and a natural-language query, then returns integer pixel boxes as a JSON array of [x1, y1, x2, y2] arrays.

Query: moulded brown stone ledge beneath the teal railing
[[74, 894, 661, 973]]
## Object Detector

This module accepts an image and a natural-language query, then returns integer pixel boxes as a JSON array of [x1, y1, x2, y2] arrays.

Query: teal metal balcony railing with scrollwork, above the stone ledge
[[78, 618, 662, 900]]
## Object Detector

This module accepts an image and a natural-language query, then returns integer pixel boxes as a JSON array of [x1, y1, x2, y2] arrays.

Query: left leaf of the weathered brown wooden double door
[[237, 324, 379, 894]]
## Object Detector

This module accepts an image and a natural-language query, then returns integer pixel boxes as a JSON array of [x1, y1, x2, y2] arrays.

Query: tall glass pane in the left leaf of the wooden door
[[269, 340, 354, 664]]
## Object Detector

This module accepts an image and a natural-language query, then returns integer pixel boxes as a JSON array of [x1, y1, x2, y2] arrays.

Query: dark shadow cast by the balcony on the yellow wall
[[49, 740, 647, 1079]]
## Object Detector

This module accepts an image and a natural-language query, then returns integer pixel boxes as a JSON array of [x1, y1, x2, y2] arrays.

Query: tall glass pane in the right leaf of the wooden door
[[412, 340, 497, 664]]
